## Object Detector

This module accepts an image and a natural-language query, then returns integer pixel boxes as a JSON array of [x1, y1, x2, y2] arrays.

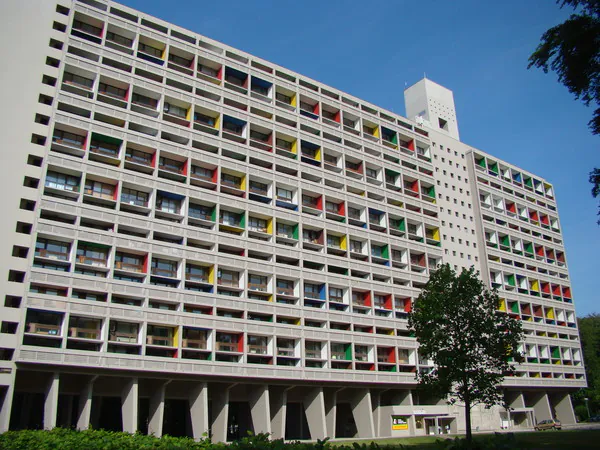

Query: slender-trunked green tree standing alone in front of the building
[[408, 264, 523, 443]]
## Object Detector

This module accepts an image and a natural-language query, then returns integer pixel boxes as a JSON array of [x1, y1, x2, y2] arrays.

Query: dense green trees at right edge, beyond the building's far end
[[573, 314, 600, 416]]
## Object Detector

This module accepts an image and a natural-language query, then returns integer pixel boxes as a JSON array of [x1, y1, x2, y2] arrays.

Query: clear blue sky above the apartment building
[[121, 0, 600, 316]]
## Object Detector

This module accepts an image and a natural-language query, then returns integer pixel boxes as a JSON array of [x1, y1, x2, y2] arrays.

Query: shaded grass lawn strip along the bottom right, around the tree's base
[[332, 429, 600, 450]]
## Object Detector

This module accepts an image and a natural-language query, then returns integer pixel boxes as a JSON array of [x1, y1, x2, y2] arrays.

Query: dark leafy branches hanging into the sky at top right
[[528, 0, 600, 225]]
